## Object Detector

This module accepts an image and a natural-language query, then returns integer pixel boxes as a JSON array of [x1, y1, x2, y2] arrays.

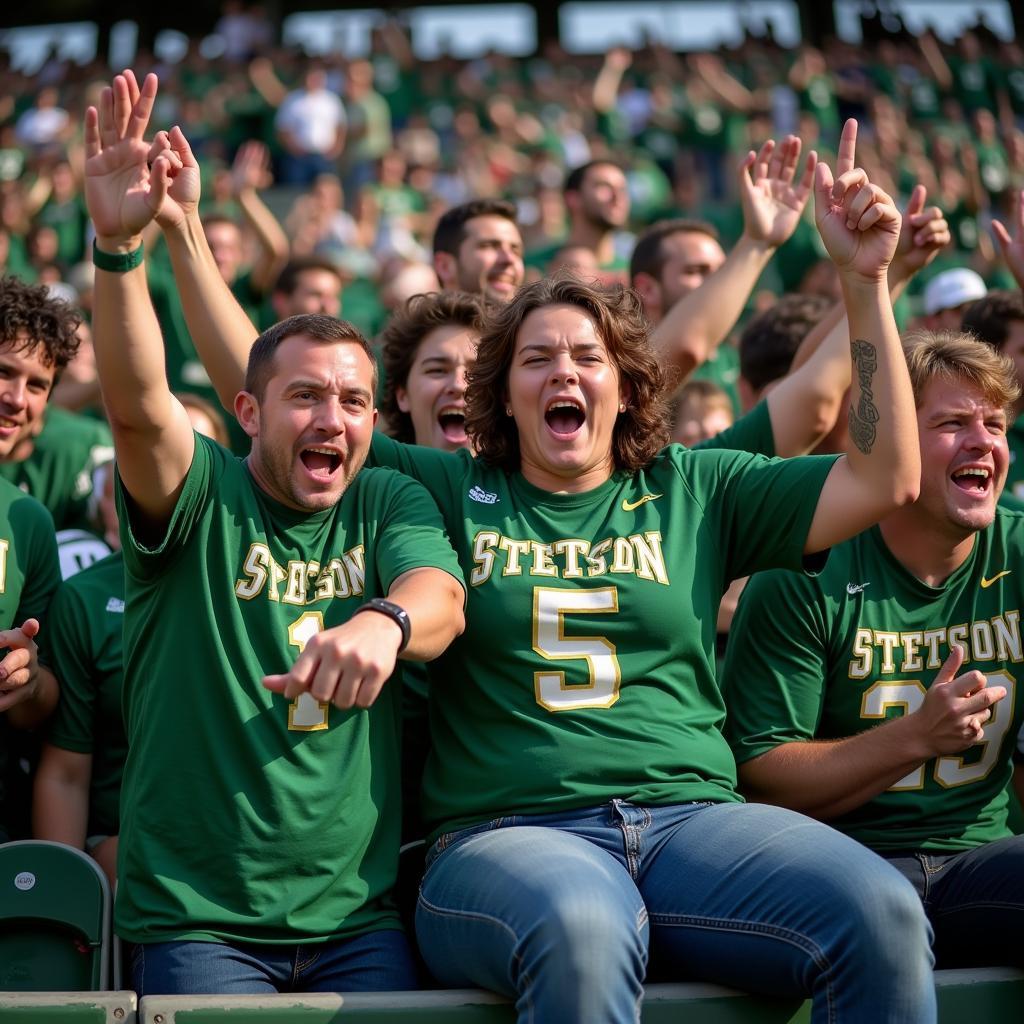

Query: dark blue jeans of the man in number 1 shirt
[[131, 929, 417, 996]]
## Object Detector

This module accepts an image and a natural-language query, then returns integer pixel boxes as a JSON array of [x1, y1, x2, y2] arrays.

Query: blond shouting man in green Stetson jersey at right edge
[[723, 334, 1024, 967]]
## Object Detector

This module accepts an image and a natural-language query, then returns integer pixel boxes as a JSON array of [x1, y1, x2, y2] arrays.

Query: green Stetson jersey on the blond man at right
[[723, 509, 1024, 852]]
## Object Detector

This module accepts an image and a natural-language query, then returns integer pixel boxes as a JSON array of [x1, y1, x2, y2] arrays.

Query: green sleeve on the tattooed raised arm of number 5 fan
[[680, 449, 838, 580]]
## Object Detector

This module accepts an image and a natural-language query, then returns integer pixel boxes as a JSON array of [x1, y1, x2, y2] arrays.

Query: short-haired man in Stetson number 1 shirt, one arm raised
[[85, 73, 464, 994]]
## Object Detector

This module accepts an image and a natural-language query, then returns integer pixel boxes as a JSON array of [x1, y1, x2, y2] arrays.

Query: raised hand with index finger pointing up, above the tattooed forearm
[[814, 119, 901, 281]]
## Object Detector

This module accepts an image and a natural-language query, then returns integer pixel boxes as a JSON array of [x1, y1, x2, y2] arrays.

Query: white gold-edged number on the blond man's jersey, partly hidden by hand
[[860, 672, 1017, 793]]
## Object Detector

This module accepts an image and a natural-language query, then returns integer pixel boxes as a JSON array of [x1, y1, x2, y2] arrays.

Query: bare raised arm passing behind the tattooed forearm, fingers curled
[[766, 185, 949, 458]]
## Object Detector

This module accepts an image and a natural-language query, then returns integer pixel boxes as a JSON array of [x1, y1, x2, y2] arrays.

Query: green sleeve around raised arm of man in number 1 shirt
[[116, 432, 214, 580]]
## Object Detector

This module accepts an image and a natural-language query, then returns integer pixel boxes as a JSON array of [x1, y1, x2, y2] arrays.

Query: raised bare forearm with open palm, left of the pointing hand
[[650, 135, 817, 384]]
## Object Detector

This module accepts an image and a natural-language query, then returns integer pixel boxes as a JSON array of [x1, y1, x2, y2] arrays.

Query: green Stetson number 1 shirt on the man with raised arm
[[116, 435, 462, 944]]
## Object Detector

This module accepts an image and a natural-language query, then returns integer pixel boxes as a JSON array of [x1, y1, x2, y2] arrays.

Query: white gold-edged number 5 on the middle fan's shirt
[[534, 587, 622, 711]]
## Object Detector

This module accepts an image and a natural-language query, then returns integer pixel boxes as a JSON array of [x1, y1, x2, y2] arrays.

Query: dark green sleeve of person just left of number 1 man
[[39, 583, 96, 754]]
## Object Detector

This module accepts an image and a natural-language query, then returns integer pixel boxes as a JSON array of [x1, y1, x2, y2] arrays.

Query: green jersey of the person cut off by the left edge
[[0, 480, 60, 842]]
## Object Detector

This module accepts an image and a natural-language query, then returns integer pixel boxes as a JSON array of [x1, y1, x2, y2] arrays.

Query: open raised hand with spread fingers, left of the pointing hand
[[738, 135, 817, 246]]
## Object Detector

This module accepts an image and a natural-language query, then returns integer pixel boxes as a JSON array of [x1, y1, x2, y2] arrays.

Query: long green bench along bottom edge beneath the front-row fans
[[134, 968, 1024, 1024]]
